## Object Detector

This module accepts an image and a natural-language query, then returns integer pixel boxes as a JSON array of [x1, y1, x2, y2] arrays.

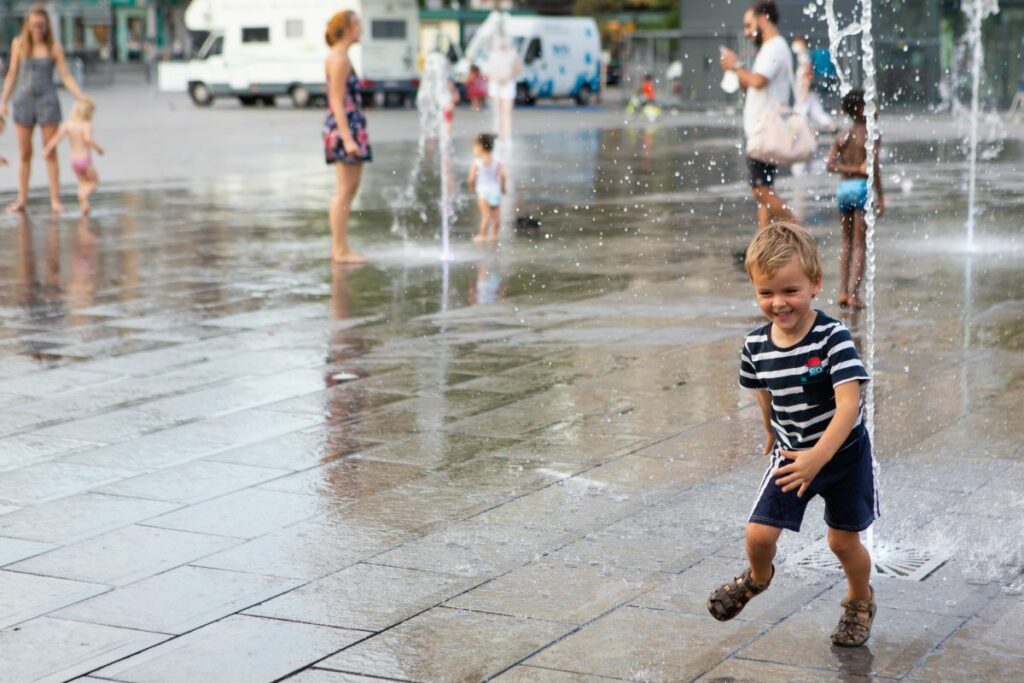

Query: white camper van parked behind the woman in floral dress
[[185, 0, 420, 106]]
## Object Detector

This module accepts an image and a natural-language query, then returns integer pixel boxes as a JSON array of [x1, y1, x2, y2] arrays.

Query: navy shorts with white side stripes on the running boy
[[750, 426, 879, 531]]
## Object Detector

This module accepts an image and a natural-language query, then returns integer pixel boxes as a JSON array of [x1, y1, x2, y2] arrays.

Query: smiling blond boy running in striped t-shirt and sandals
[[708, 222, 878, 647]]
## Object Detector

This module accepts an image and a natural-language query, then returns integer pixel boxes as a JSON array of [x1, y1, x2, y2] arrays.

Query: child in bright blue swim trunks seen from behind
[[828, 90, 886, 308]]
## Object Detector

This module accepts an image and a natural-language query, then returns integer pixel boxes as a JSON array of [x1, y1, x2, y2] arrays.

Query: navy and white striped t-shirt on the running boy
[[739, 310, 869, 451]]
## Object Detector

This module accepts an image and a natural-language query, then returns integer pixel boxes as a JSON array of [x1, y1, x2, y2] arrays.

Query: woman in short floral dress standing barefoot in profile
[[324, 9, 373, 263]]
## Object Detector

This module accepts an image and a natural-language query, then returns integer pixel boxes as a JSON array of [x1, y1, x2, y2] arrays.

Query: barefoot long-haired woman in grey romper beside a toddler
[[0, 5, 88, 213]]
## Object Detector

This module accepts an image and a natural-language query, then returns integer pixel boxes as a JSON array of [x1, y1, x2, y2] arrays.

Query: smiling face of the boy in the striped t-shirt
[[751, 255, 821, 343]]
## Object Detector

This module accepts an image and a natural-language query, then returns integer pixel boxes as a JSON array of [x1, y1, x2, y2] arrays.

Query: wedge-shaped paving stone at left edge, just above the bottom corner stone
[[0, 569, 110, 629]]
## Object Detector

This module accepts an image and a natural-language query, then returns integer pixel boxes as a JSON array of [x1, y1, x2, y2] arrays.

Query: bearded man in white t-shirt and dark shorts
[[721, 0, 794, 228]]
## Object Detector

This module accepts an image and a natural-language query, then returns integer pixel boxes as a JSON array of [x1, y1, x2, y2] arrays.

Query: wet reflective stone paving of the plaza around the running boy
[[0, 129, 1024, 682]]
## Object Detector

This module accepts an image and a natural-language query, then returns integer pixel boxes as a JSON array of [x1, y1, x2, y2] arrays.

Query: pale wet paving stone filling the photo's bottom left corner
[[0, 616, 167, 683]]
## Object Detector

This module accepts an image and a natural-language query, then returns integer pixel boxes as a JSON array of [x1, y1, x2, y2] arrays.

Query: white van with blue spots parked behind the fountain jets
[[456, 12, 601, 104]]
